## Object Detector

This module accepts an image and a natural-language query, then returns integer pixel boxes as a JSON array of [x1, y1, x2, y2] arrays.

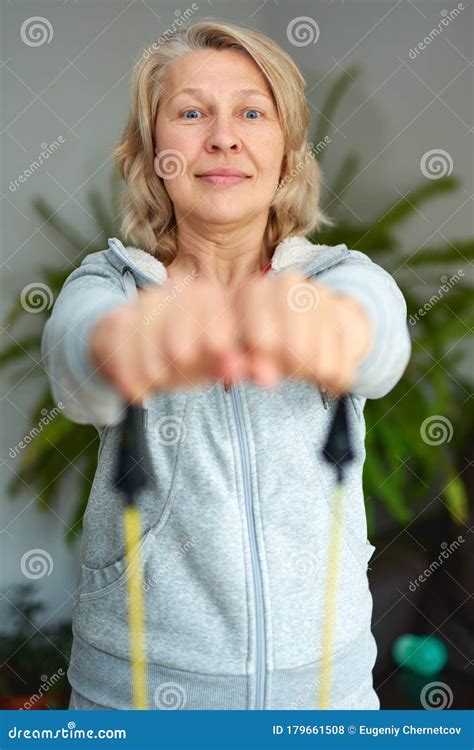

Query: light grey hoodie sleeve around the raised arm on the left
[[41, 251, 128, 426]]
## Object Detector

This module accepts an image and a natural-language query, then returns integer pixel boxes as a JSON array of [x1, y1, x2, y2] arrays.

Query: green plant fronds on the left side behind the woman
[[0, 173, 124, 545]]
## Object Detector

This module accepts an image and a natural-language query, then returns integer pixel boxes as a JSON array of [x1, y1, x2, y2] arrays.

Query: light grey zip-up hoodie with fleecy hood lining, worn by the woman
[[42, 236, 411, 710]]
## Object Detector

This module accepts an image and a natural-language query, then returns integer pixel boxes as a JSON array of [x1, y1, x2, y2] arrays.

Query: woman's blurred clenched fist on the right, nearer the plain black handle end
[[227, 270, 373, 395]]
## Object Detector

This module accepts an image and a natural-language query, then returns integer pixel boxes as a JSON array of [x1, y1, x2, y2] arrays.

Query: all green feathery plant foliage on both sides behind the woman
[[0, 67, 474, 542]]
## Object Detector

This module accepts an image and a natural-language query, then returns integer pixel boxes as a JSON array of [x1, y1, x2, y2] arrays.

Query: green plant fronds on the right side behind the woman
[[309, 67, 474, 529]]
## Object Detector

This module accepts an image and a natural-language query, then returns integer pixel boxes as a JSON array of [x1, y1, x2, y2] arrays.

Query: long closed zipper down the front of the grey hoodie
[[224, 381, 266, 711]]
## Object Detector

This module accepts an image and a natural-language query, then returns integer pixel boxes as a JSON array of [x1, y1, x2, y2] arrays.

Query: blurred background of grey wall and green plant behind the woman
[[0, 0, 474, 709]]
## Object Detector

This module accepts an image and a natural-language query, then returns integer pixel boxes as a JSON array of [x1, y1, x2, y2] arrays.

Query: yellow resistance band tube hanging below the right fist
[[316, 482, 343, 711]]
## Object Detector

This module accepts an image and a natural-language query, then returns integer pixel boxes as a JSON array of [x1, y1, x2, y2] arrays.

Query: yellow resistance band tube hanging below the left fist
[[123, 505, 148, 710]]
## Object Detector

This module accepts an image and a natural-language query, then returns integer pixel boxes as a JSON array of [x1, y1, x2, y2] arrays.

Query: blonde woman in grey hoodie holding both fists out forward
[[42, 21, 410, 710]]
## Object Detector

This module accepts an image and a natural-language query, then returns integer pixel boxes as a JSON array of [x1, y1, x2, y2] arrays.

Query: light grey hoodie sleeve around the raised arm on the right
[[312, 250, 412, 398]]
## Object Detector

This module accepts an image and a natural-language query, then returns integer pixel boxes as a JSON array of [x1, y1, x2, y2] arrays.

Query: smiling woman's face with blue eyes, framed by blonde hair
[[155, 50, 284, 226]]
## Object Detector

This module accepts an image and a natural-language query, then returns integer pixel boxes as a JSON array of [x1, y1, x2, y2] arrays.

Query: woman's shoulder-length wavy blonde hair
[[113, 21, 333, 265]]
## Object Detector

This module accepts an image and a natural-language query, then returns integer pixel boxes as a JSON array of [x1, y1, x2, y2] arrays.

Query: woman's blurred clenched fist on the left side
[[89, 279, 248, 404]]
